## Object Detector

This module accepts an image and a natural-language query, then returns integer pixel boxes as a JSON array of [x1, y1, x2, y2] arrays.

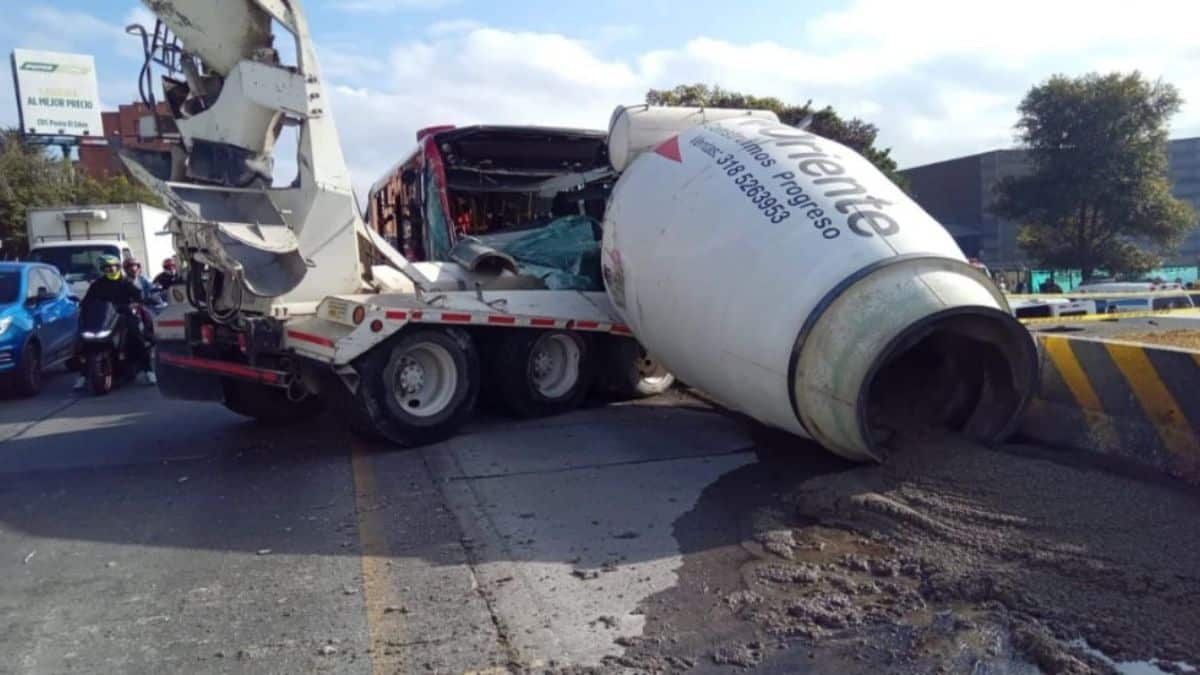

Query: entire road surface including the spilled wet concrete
[[0, 382, 1200, 674]]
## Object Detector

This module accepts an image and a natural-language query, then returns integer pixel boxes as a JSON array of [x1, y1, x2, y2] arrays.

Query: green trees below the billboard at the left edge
[[0, 130, 161, 246]]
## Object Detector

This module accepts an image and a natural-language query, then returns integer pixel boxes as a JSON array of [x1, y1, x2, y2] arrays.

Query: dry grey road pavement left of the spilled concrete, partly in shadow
[[0, 375, 842, 673]]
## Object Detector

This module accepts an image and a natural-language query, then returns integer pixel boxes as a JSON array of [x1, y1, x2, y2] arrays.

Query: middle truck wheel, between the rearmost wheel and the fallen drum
[[490, 329, 595, 418]]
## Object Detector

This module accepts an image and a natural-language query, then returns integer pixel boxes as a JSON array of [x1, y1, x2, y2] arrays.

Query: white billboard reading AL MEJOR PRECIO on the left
[[12, 49, 104, 138]]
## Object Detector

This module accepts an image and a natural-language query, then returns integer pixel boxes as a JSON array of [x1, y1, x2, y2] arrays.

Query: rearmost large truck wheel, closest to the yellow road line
[[350, 328, 479, 447]]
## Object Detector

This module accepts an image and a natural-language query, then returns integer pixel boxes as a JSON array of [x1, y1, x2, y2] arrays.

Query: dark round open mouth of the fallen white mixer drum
[[859, 307, 1037, 456]]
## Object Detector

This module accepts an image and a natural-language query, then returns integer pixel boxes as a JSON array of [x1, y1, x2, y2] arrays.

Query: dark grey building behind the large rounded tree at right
[[900, 138, 1200, 267]]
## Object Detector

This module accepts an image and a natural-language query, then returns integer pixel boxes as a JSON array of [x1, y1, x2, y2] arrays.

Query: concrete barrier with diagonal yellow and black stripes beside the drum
[[1021, 334, 1200, 483]]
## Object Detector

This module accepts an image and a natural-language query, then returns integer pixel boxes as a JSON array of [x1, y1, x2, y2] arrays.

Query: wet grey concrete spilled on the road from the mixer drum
[[592, 425, 1200, 674]]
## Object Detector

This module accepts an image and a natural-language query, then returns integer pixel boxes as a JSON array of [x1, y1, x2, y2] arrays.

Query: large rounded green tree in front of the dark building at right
[[992, 71, 1196, 281]]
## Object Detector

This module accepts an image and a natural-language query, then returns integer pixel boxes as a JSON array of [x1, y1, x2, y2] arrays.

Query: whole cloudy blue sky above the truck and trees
[[0, 0, 1200, 190]]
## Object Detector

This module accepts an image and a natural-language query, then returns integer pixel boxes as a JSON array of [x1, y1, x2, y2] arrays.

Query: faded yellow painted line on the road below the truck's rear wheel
[[350, 440, 403, 675]]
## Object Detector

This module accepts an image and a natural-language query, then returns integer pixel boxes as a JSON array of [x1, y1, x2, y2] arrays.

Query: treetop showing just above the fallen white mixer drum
[[646, 84, 908, 190]]
